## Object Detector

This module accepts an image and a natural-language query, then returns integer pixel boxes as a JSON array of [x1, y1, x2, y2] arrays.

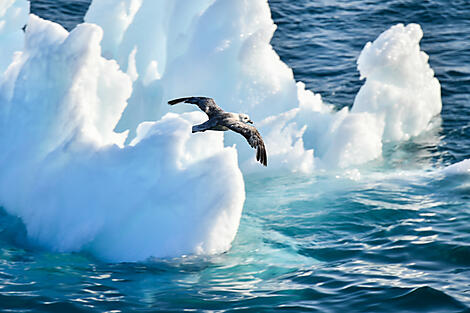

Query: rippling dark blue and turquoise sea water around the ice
[[0, 0, 470, 312]]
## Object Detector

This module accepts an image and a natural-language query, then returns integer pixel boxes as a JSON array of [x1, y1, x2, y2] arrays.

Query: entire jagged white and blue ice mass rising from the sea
[[0, 0, 448, 261]]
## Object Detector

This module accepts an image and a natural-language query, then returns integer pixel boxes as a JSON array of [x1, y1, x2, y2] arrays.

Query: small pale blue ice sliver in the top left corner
[[0, 0, 29, 74]]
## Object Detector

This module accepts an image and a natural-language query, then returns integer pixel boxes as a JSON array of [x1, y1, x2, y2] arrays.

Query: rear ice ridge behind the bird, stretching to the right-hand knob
[[85, 0, 441, 172]]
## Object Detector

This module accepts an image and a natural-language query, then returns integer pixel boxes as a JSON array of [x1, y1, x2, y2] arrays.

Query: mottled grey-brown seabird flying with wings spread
[[168, 97, 268, 166]]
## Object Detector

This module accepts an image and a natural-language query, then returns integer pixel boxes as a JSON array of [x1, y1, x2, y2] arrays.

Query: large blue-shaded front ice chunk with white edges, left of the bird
[[0, 15, 245, 261]]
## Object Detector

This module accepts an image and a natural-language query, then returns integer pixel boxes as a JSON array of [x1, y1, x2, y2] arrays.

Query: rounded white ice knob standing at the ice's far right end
[[352, 24, 442, 141]]
